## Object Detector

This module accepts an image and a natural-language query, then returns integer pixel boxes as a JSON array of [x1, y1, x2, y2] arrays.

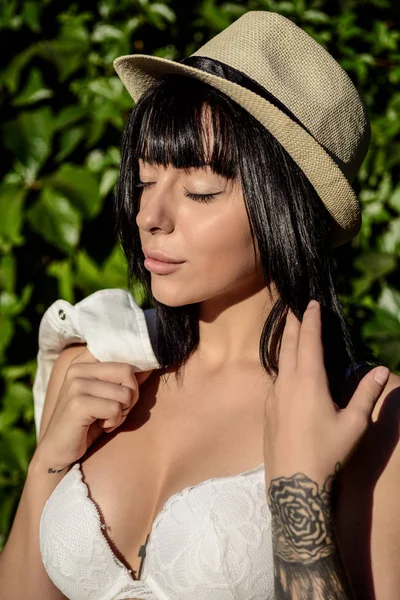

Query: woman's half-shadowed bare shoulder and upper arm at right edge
[[334, 367, 400, 600]]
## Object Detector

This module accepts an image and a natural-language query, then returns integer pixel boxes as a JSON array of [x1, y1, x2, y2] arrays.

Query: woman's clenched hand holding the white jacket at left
[[35, 348, 152, 471]]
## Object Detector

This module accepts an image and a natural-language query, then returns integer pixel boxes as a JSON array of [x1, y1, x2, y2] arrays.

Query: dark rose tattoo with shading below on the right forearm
[[268, 463, 354, 600]]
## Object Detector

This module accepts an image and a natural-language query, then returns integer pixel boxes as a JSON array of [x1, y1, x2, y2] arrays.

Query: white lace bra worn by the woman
[[40, 463, 274, 600]]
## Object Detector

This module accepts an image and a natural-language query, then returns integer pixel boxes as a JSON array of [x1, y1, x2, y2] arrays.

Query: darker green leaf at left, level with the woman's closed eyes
[[46, 164, 102, 219]]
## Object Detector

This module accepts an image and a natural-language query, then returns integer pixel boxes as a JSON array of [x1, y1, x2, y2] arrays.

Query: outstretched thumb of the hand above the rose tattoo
[[340, 366, 390, 435]]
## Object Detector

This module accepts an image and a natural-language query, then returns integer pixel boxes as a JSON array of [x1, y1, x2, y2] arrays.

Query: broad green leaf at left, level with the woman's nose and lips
[[27, 185, 82, 254]]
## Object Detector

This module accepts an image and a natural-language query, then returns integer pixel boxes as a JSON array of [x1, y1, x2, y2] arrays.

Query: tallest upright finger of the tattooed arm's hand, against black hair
[[297, 300, 325, 377]]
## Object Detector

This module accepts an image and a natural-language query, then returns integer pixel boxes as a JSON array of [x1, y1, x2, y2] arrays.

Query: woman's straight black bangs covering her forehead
[[128, 75, 238, 179]]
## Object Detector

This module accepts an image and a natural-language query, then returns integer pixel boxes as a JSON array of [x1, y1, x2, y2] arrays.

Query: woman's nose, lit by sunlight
[[136, 184, 174, 233]]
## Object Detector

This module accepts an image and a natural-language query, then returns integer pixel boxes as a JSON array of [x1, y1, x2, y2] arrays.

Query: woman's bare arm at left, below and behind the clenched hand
[[0, 345, 86, 600]]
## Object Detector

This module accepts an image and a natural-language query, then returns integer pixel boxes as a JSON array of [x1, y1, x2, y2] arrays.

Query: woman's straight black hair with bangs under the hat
[[114, 74, 378, 398]]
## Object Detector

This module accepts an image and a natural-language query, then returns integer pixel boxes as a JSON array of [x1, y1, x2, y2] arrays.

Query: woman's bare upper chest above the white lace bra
[[81, 370, 269, 576]]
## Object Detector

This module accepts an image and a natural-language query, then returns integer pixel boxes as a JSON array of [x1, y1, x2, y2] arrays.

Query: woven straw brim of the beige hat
[[114, 54, 361, 246]]
